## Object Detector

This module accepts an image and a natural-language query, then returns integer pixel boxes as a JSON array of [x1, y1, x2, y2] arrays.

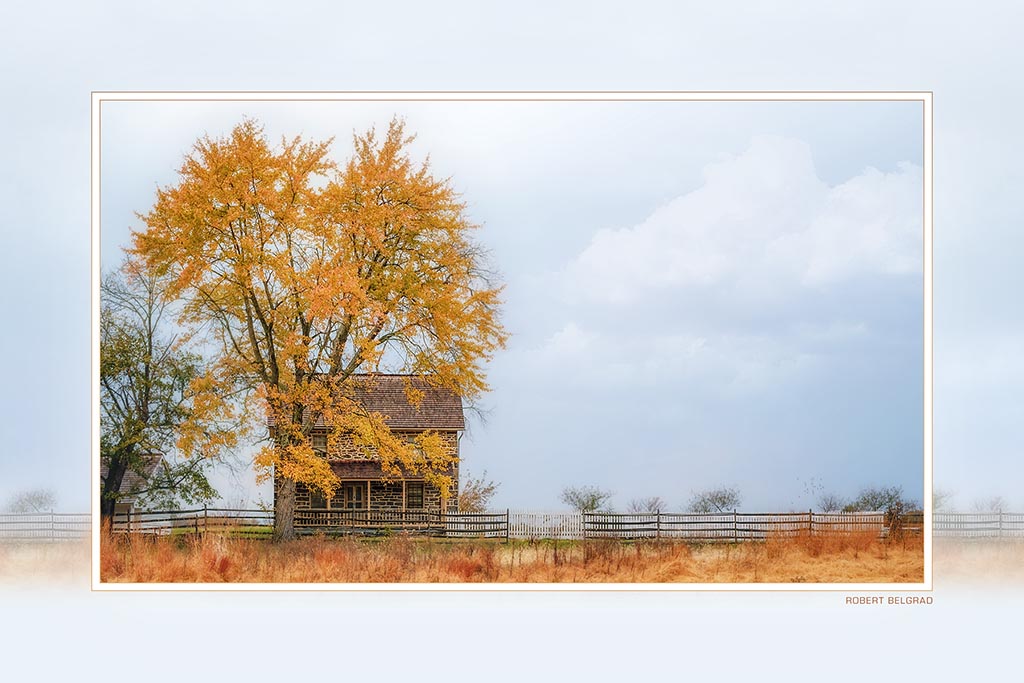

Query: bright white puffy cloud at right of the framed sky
[[562, 137, 923, 304]]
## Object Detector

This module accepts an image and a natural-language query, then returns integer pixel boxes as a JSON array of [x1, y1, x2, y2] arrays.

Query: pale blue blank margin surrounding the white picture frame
[[0, 2, 1024, 680]]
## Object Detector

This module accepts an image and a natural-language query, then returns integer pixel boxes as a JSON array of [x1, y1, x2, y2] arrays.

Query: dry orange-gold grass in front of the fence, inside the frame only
[[86, 535, 924, 584]]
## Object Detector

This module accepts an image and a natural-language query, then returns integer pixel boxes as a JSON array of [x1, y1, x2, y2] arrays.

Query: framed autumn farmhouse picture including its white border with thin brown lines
[[92, 91, 933, 591]]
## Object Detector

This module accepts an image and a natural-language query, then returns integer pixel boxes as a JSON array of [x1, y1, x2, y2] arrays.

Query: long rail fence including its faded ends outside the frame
[[6, 508, 1024, 543]]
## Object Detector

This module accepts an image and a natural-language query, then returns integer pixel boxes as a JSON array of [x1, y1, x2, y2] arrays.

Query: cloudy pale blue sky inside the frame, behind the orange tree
[[101, 102, 923, 510]]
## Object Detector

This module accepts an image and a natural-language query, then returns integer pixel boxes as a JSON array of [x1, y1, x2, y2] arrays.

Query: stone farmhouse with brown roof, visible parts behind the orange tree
[[271, 374, 466, 513]]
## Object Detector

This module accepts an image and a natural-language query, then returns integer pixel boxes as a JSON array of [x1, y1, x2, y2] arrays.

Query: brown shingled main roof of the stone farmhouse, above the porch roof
[[267, 375, 466, 431]]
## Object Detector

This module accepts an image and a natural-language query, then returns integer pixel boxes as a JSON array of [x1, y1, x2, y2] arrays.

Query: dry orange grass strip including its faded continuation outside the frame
[[12, 537, 1024, 588]]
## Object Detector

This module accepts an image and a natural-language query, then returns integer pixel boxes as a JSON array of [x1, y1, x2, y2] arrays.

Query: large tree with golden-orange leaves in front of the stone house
[[133, 120, 506, 539]]
